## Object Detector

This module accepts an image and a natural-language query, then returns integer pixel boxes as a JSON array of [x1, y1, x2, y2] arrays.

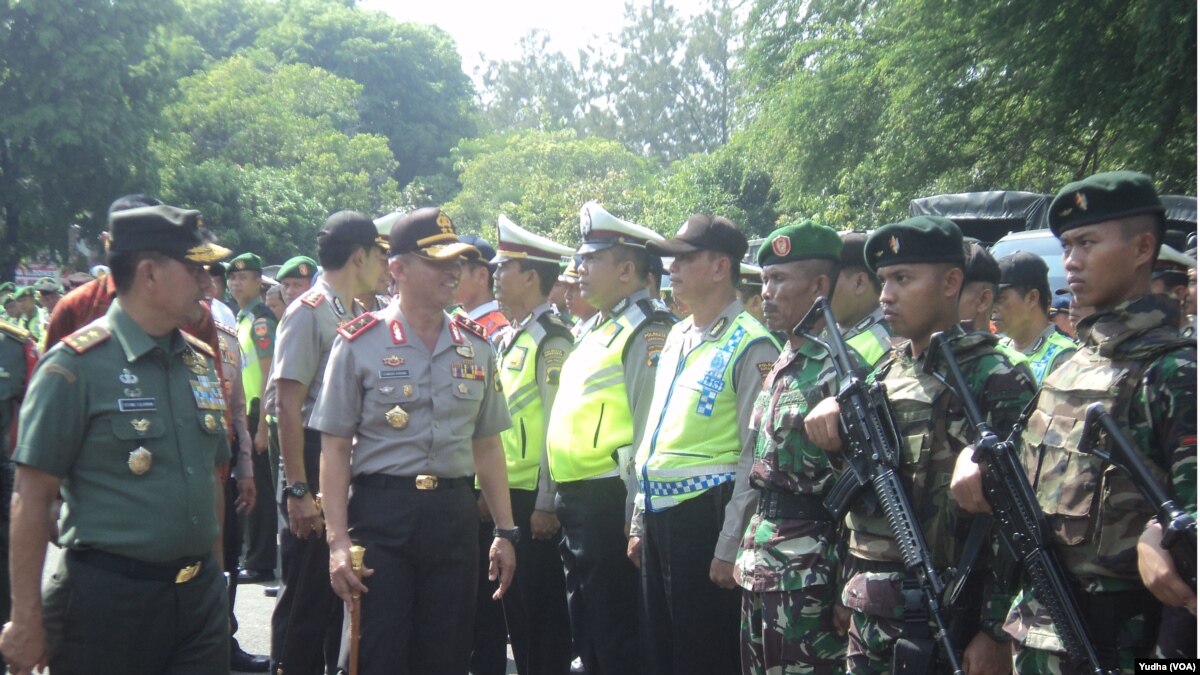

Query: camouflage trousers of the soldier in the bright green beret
[[742, 585, 846, 675]]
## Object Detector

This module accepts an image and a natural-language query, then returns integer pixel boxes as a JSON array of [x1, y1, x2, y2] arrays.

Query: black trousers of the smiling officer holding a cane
[[348, 473, 479, 675]]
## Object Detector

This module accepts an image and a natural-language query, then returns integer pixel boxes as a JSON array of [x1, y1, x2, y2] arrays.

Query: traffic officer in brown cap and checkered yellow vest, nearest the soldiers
[[630, 215, 779, 675]]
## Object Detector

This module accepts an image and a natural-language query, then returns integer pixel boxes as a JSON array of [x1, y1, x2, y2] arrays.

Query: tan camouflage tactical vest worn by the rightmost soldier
[[1021, 340, 1190, 581]]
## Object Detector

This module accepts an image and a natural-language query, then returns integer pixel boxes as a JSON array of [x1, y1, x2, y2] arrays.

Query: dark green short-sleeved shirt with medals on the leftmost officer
[[13, 299, 229, 562]]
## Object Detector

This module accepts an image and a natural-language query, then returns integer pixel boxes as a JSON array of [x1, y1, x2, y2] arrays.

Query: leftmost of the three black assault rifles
[[794, 297, 962, 675]]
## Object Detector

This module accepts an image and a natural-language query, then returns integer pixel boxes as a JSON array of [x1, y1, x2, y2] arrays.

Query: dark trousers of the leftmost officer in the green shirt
[[42, 551, 229, 675]]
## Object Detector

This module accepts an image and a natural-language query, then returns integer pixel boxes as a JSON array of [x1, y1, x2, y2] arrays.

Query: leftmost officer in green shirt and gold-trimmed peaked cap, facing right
[[0, 205, 229, 675]]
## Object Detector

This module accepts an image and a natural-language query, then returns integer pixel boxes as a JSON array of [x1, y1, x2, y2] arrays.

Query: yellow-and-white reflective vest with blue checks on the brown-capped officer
[[637, 312, 770, 512]]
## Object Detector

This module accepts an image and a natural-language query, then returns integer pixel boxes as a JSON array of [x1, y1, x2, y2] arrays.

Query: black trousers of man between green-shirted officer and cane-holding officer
[[266, 429, 343, 675]]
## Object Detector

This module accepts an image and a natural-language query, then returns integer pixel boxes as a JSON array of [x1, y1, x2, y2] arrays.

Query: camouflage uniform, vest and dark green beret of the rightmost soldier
[[1006, 172, 1196, 673]]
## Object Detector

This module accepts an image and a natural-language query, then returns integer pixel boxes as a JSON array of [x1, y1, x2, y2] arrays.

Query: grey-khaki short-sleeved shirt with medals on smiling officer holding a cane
[[308, 301, 511, 478]]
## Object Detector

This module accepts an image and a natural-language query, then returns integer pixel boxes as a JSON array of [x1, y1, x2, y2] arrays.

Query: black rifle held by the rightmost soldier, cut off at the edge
[[1079, 402, 1196, 591]]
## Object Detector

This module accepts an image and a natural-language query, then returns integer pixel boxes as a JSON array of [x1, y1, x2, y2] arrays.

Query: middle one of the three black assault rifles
[[924, 333, 1110, 675]]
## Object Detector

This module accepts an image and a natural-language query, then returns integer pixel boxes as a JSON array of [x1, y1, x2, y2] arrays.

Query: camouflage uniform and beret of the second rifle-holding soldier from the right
[[842, 217, 1036, 673]]
